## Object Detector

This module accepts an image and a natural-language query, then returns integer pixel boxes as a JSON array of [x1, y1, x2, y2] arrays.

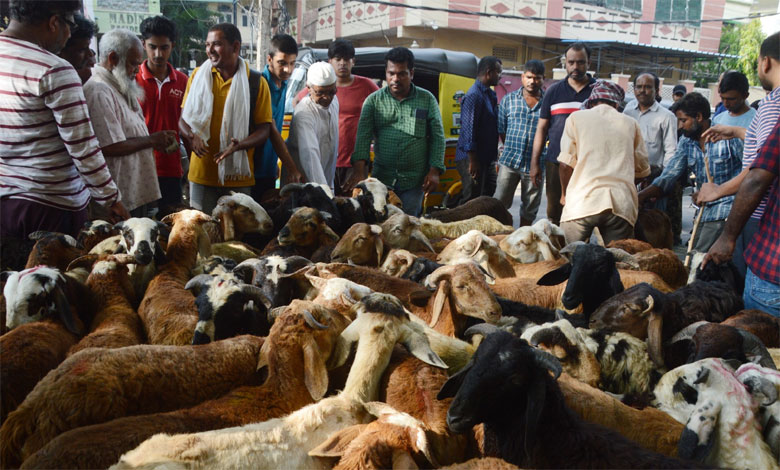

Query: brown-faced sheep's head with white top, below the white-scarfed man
[[211, 191, 274, 241]]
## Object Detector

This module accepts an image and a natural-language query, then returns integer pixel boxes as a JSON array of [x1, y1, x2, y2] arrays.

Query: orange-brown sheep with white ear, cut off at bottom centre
[[309, 402, 439, 470]]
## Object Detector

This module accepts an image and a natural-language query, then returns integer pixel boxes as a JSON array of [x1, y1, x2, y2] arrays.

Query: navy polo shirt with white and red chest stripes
[[539, 75, 596, 163]]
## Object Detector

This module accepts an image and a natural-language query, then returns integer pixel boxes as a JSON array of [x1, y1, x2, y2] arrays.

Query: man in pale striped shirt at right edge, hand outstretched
[[697, 33, 780, 280]]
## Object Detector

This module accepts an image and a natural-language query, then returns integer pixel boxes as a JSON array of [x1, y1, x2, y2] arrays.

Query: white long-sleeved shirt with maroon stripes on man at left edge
[[0, 36, 119, 211]]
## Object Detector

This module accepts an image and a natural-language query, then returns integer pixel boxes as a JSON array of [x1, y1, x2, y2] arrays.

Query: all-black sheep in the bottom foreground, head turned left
[[438, 331, 691, 468]]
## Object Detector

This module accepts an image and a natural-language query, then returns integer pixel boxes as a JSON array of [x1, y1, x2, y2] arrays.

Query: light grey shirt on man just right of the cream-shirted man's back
[[623, 100, 677, 167]]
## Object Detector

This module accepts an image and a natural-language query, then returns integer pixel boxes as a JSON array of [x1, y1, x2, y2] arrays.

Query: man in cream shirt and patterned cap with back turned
[[558, 80, 655, 243]]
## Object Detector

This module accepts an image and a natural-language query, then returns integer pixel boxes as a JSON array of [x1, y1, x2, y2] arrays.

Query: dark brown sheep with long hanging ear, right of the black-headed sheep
[[589, 281, 742, 366]]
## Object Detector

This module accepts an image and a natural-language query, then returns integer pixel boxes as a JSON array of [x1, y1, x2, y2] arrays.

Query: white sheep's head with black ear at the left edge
[[0, 266, 85, 336]]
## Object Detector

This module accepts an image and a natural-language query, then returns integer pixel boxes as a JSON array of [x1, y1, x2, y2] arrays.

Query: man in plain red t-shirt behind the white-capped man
[[328, 39, 379, 196]]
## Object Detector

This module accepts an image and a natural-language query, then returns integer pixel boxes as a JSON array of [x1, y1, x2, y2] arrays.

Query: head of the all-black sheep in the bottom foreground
[[437, 331, 562, 436]]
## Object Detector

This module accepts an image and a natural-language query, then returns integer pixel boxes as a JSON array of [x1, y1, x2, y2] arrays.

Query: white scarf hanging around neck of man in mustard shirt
[[181, 57, 252, 184]]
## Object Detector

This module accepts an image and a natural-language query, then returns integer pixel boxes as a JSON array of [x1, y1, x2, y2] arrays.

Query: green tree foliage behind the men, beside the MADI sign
[[160, 0, 218, 68]]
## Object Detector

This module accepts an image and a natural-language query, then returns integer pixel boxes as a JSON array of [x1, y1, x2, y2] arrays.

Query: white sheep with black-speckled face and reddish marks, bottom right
[[669, 358, 780, 469]]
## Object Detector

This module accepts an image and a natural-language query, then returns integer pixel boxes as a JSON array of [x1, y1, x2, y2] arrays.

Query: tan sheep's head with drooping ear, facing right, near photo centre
[[425, 262, 501, 326]]
